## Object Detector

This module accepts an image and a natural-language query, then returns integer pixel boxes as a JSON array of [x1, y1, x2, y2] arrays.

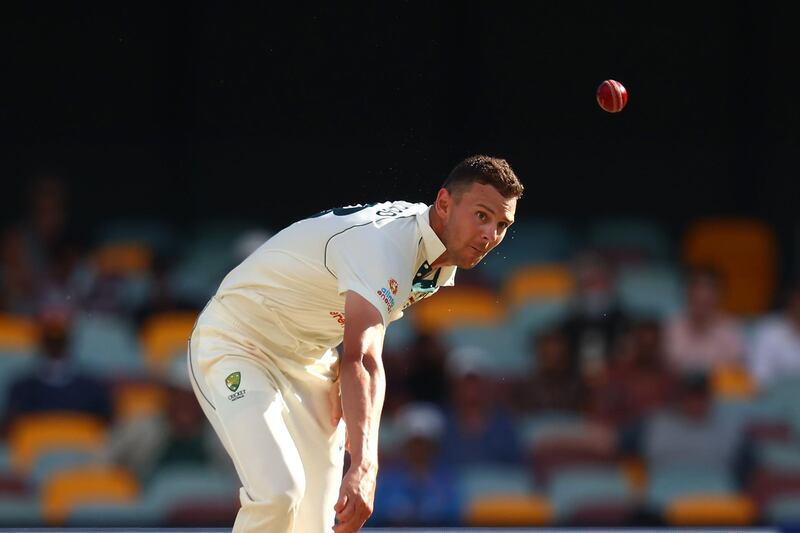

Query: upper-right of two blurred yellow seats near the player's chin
[[503, 264, 575, 307]]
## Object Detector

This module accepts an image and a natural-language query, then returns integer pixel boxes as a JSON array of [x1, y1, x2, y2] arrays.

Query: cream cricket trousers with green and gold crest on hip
[[188, 300, 345, 533]]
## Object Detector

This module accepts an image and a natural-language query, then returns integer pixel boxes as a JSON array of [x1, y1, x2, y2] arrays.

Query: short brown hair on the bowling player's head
[[442, 155, 524, 198]]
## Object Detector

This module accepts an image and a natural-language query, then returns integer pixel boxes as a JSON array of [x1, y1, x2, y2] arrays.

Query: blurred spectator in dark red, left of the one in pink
[[589, 319, 675, 453]]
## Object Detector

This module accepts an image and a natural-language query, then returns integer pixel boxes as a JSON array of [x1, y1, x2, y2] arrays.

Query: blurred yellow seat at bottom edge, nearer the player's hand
[[466, 494, 553, 527]]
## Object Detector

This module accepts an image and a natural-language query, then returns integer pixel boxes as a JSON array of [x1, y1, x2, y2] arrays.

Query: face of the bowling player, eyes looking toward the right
[[436, 183, 517, 268]]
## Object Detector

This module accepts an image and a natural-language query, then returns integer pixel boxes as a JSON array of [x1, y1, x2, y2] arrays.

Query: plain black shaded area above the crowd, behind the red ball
[[0, 1, 800, 243]]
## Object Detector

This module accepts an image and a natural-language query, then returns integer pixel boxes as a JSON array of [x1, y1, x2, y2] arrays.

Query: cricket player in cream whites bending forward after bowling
[[188, 156, 523, 533]]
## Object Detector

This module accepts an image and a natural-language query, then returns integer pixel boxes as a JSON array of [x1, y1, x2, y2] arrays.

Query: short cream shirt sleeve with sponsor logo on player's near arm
[[325, 226, 409, 326]]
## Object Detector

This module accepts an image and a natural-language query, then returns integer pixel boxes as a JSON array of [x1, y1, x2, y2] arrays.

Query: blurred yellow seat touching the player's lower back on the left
[[140, 312, 197, 372]]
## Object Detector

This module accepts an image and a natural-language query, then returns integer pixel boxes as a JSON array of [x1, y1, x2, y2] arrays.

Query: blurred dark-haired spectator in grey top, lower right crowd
[[643, 372, 745, 473]]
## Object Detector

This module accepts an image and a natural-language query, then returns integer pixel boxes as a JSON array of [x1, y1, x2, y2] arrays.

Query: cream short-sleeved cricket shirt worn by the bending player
[[206, 202, 456, 374]]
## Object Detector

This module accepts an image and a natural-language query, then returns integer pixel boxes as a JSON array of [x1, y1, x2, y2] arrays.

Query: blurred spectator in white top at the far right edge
[[749, 281, 800, 387]]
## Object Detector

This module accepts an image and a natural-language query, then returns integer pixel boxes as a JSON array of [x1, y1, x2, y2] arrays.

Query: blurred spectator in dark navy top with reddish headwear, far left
[[0, 308, 112, 430]]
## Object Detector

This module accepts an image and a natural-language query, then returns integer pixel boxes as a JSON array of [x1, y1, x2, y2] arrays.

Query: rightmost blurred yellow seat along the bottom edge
[[665, 495, 758, 527]]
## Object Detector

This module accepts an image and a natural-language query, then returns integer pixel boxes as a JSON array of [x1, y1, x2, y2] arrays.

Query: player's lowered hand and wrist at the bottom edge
[[333, 465, 377, 533]]
